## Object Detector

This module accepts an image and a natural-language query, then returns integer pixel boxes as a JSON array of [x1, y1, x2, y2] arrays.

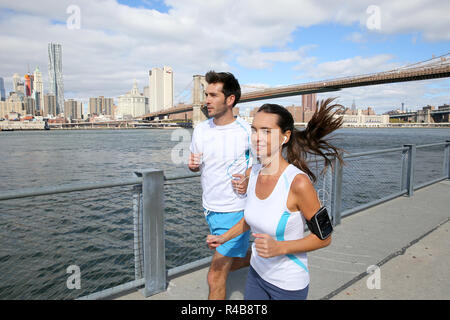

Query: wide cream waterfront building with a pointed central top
[[115, 80, 148, 119]]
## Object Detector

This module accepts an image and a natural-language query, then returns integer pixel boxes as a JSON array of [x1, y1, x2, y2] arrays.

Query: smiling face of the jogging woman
[[251, 111, 287, 159]]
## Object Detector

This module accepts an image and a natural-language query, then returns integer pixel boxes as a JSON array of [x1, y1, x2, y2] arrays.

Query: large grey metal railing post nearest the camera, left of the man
[[137, 170, 166, 297]]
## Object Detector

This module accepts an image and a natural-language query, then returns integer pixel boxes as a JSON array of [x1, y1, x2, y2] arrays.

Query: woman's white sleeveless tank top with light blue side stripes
[[244, 164, 309, 290]]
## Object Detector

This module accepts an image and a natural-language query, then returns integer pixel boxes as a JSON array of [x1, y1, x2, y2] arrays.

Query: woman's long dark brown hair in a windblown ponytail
[[258, 98, 344, 182]]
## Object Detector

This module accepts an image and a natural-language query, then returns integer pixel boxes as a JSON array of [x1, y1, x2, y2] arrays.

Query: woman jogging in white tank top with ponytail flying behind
[[207, 99, 342, 300]]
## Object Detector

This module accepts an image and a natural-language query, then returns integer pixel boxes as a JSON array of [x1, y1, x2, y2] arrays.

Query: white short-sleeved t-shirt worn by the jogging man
[[189, 117, 252, 212]]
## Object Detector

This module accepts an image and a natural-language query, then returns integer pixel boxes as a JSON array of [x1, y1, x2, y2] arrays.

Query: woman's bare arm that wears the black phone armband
[[253, 174, 331, 258]]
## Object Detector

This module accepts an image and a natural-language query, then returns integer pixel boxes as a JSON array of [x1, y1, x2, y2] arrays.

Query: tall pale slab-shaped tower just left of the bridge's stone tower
[[149, 66, 173, 112]]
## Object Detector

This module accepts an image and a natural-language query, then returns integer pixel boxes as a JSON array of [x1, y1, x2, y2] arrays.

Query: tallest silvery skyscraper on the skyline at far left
[[48, 43, 64, 114]]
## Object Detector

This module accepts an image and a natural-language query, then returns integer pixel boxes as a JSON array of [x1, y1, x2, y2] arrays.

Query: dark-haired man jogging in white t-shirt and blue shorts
[[188, 71, 251, 299]]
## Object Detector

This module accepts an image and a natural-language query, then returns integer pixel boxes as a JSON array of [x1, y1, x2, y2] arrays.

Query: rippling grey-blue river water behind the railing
[[0, 128, 450, 299]]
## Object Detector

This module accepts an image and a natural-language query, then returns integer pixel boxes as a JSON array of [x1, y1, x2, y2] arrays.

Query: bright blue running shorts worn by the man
[[204, 209, 250, 258]]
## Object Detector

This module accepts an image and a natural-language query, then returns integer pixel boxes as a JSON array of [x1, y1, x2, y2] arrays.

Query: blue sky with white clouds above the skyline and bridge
[[0, 0, 450, 114]]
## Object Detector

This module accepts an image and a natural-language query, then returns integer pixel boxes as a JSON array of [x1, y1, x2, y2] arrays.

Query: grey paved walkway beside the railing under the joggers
[[116, 180, 450, 300]]
